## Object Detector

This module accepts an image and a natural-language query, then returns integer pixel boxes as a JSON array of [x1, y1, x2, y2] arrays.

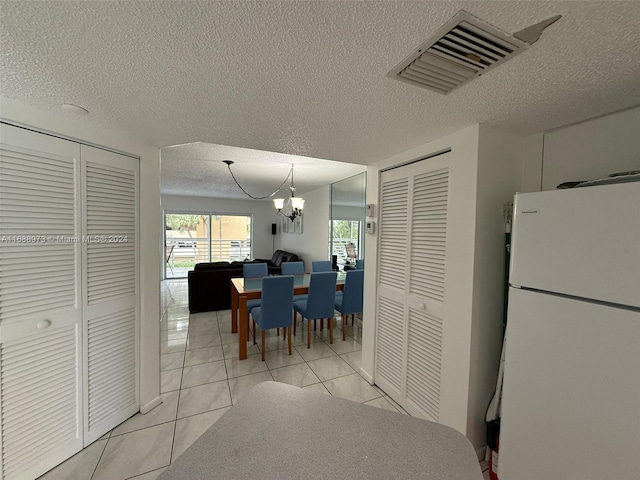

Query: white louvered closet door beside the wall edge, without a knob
[[82, 145, 139, 445]]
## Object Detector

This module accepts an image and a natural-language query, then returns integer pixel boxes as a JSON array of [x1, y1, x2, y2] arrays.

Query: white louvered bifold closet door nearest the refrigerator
[[375, 154, 449, 421]]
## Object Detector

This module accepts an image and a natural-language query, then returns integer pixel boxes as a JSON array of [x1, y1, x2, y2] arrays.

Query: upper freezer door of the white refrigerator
[[509, 182, 640, 306]]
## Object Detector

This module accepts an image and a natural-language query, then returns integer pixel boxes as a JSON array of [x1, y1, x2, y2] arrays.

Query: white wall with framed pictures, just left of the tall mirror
[[278, 185, 329, 272]]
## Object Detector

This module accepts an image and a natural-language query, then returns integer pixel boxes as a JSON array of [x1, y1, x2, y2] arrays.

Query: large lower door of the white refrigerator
[[498, 288, 640, 480]]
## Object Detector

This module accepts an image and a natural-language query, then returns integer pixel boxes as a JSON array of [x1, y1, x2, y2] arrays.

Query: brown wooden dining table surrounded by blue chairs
[[231, 272, 346, 360]]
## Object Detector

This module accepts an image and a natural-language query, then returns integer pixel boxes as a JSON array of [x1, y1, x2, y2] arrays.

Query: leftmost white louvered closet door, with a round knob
[[0, 124, 82, 480]]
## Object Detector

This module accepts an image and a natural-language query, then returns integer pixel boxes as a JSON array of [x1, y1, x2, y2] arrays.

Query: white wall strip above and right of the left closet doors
[[0, 97, 162, 410]]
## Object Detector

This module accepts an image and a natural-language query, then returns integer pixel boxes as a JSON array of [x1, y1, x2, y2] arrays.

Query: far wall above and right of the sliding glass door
[[161, 195, 278, 258]]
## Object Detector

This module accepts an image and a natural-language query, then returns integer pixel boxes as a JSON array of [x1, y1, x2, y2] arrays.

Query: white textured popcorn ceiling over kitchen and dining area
[[0, 0, 640, 197]]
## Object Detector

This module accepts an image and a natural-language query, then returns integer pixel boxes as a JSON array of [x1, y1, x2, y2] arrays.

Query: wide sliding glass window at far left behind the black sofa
[[164, 213, 251, 278]]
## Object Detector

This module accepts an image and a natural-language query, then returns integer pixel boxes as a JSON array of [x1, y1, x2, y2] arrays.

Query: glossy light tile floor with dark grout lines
[[40, 279, 488, 480]]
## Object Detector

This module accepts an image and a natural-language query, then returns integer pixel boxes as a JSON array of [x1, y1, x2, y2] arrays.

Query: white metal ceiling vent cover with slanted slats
[[387, 11, 529, 94]]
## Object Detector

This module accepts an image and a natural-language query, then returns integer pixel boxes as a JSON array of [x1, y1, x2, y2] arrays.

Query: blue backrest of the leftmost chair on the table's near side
[[260, 275, 293, 330]]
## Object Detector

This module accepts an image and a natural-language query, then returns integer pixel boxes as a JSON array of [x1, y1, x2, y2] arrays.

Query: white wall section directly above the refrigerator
[[542, 107, 640, 190]]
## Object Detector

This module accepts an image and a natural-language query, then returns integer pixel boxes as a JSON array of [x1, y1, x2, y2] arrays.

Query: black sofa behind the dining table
[[187, 250, 298, 313]]
